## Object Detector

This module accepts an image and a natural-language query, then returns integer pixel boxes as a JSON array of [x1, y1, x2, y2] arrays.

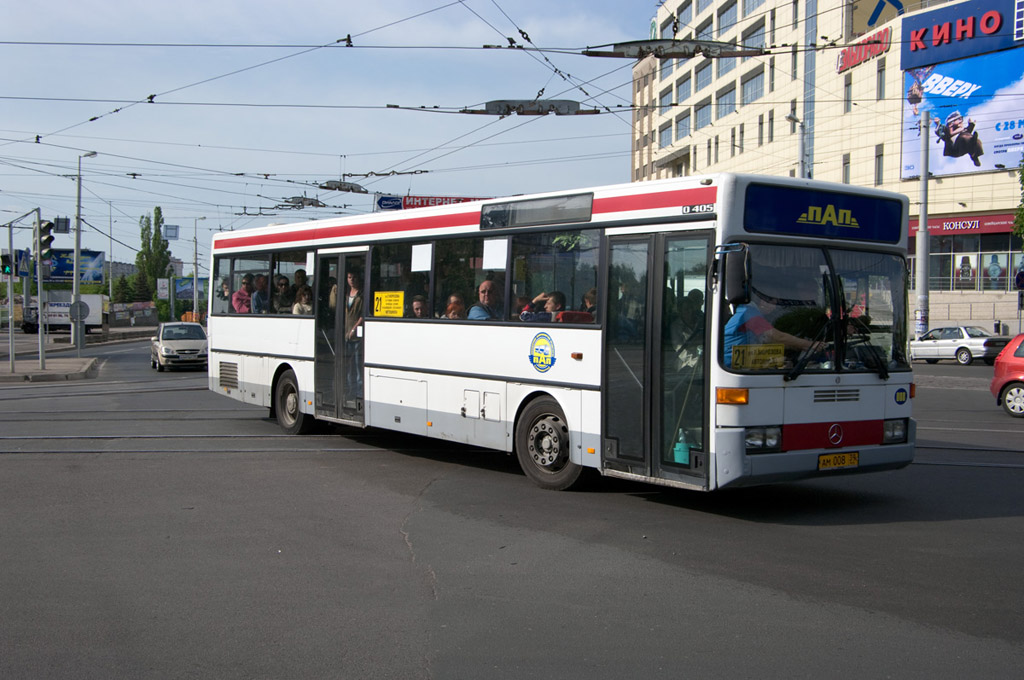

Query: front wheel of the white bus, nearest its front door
[[515, 396, 583, 491]]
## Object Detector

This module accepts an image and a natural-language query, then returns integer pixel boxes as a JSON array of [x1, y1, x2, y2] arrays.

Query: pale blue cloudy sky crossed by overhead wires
[[0, 0, 657, 274]]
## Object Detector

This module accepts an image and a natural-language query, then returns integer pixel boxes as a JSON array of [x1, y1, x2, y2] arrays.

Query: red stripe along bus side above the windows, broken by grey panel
[[214, 186, 717, 250]]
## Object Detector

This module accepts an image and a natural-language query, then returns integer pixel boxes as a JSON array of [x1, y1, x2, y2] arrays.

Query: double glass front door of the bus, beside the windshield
[[602, 231, 711, 487]]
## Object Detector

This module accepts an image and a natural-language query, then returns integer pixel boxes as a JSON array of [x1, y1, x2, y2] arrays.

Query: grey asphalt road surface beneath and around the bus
[[0, 344, 1024, 679]]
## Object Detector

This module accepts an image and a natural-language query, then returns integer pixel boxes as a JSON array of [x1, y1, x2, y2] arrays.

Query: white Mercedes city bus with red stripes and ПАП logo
[[209, 174, 915, 490]]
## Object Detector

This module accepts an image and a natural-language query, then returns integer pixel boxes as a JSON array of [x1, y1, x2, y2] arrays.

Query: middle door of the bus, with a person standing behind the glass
[[313, 253, 367, 425]]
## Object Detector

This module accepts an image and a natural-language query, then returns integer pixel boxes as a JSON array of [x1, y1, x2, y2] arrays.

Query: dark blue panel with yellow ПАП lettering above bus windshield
[[743, 183, 903, 244]]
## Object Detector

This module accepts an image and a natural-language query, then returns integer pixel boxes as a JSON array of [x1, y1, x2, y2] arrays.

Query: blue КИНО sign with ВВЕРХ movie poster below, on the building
[[900, 0, 1024, 179]]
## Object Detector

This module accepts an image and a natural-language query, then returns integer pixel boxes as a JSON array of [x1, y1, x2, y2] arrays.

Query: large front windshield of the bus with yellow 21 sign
[[722, 244, 910, 380]]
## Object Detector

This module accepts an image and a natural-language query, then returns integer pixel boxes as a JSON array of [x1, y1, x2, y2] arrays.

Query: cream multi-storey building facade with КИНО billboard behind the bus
[[632, 0, 1024, 332]]
